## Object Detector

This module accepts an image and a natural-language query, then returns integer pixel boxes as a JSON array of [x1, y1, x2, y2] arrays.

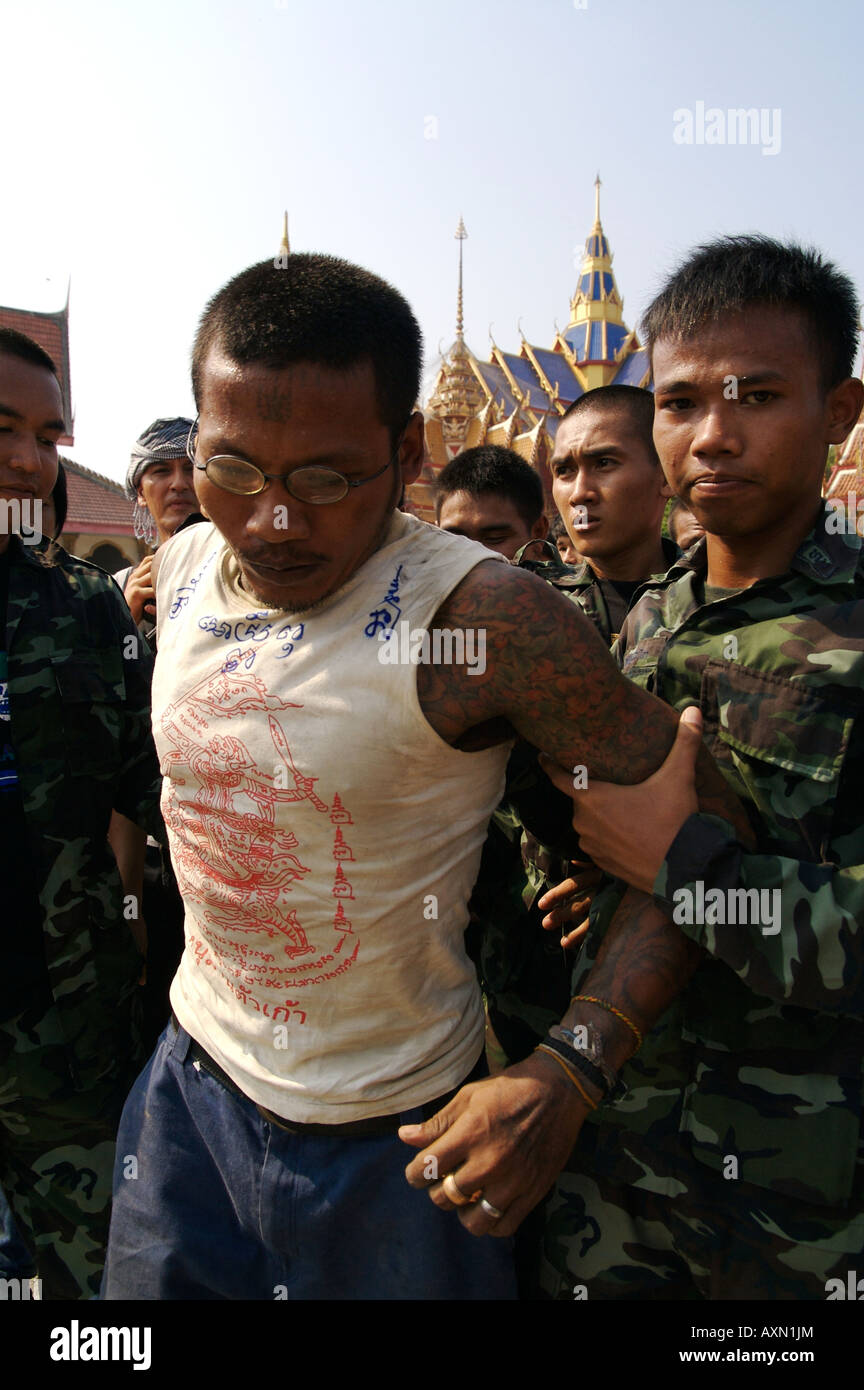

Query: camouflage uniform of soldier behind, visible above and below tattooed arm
[[471, 541, 678, 1062]]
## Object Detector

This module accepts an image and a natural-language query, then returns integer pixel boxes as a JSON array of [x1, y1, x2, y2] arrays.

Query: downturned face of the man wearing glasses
[[194, 353, 422, 613]]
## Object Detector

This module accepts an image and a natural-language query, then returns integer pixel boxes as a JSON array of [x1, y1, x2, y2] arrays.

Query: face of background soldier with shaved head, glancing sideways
[[550, 406, 668, 563]]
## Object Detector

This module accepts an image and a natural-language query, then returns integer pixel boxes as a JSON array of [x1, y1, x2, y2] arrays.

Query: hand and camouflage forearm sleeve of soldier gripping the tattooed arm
[[545, 712, 864, 1017]]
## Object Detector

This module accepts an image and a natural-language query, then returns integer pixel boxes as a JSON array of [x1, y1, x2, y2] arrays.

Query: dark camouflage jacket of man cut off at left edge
[[6, 537, 161, 1088]]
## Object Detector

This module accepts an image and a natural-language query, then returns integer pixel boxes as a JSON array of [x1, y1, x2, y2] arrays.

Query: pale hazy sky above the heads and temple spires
[[0, 0, 864, 489]]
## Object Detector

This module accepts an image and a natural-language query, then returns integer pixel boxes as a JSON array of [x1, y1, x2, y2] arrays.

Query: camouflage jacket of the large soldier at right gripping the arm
[[574, 512, 864, 1205]]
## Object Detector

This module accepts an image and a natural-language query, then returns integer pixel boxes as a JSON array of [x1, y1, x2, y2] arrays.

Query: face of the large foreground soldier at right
[[653, 307, 854, 538]]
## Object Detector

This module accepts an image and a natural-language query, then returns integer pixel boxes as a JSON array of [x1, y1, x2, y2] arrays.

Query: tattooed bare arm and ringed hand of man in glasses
[[400, 566, 750, 1236]]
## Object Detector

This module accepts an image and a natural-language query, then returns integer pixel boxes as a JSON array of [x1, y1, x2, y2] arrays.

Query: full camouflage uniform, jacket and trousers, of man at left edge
[[0, 537, 160, 1298]]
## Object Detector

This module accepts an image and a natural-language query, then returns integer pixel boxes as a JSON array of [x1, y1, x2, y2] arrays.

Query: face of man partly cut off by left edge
[[0, 353, 64, 553]]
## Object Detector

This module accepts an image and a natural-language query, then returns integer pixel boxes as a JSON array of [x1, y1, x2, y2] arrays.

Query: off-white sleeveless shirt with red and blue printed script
[[153, 512, 511, 1125]]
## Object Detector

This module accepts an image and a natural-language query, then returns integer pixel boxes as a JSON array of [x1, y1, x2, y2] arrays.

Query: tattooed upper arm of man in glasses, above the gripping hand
[[417, 562, 747, 835]]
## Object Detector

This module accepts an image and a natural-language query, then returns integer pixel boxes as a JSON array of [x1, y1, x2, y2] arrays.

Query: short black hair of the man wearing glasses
[[192, 253, 422, 441]]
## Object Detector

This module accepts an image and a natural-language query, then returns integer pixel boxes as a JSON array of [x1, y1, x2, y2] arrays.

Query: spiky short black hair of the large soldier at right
[[642, 234, 858, 391]]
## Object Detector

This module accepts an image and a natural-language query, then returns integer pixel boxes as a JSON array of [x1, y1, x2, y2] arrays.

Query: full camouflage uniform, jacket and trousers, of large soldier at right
[[545, 513, 864, 1298]]
